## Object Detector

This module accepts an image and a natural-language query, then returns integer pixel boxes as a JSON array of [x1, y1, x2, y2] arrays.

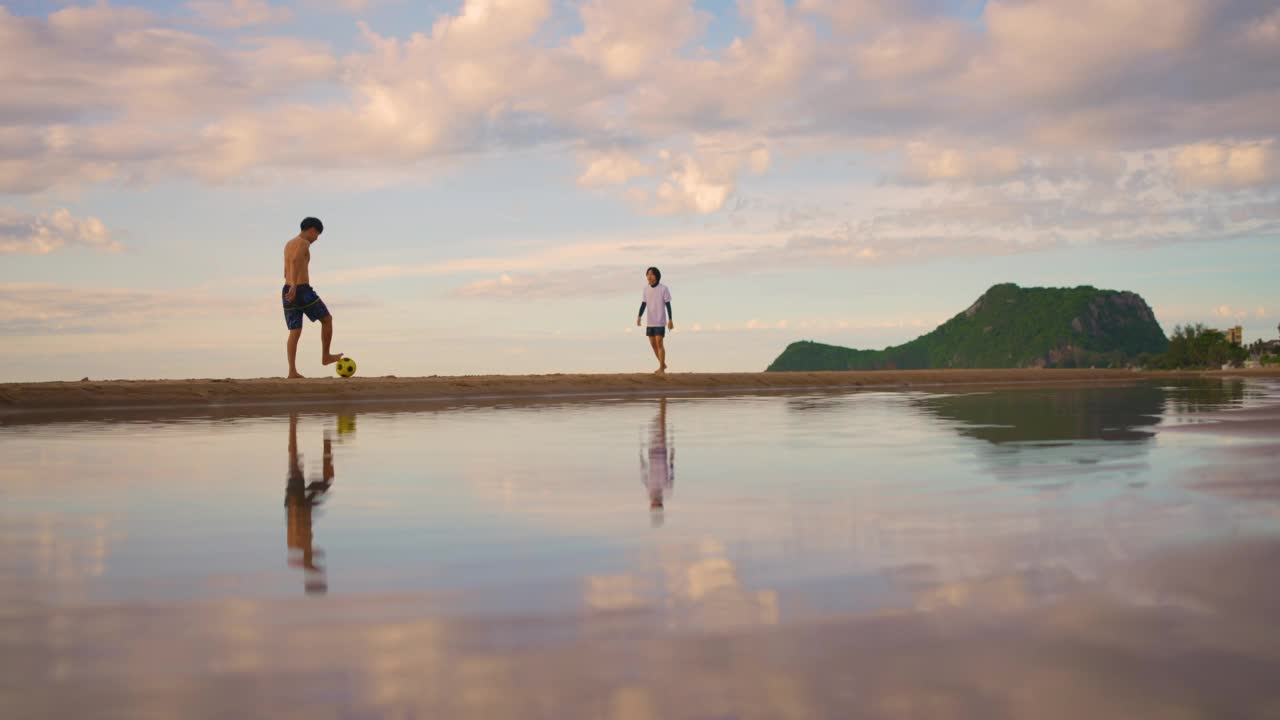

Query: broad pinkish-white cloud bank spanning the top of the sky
[[0, 0, 1280, 253]]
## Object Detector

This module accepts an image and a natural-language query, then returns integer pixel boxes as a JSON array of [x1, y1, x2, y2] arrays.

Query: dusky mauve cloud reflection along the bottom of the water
[[10, 541, 1280, 720]]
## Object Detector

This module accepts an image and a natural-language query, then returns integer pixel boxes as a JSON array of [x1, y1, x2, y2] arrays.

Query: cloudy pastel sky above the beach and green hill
[[0, 0, 1280, 382]]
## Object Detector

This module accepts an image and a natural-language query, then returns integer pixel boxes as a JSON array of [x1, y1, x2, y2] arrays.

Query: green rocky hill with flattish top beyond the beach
[[767, 283, 1169, 372]]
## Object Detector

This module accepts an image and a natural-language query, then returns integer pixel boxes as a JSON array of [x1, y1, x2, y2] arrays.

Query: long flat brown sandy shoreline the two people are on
[[0, 368, 1280, 415]]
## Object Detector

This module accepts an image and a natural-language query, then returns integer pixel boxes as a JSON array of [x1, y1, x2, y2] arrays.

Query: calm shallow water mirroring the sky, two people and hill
[[0, 380, 1280, 719]]
